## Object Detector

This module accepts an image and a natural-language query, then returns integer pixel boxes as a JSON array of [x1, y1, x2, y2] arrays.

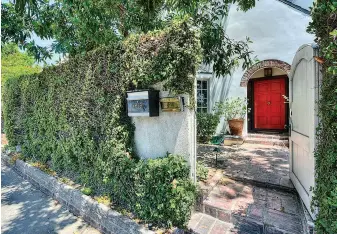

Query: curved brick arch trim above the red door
[[240, 59, 291, 87]]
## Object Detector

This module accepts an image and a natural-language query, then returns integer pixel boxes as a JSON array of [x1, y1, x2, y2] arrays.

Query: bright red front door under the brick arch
[[254, 78, 286, 129]]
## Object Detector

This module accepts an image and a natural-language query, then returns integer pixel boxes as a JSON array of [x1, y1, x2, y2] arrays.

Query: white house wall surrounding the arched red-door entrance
[[199, 0, 314, 134]]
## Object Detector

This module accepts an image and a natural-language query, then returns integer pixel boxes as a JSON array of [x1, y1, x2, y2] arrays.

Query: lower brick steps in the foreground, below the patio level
[[192, 179, 304, 234]]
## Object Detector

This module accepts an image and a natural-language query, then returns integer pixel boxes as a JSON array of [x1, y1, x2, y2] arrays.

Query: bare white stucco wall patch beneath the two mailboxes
[[132, 91, 196, 178]]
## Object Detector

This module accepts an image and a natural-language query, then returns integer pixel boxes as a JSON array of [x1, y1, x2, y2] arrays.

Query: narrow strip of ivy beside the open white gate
[[308, 0, 337, 233]]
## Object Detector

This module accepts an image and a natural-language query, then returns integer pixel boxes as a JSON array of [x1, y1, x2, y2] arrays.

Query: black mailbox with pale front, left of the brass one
[[127, 90, 159, 117]]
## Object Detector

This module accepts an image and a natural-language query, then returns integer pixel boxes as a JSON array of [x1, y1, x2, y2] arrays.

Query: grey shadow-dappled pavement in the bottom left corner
[[1, 164, 100, 234]]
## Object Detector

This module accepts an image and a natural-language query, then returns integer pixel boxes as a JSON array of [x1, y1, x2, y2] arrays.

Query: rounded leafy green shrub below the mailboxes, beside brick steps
[[134, 155, 196, 226]]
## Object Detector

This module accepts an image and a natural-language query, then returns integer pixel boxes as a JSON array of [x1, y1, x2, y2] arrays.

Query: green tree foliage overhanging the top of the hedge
[[1, 0, 255, 75]]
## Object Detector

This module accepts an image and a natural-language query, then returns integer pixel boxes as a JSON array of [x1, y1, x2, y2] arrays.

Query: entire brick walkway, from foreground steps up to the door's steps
[[189, 144, 304, 234]]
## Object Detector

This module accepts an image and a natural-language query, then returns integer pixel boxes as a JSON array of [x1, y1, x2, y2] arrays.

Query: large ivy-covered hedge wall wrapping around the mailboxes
[[3, 20, 200, 229]]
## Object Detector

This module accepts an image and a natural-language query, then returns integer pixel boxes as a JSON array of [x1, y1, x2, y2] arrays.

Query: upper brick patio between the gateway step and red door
[[197, 143, 294, 190]]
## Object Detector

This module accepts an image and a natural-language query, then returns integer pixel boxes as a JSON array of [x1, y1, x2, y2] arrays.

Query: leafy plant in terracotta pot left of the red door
[[223, 97, 249, 136]]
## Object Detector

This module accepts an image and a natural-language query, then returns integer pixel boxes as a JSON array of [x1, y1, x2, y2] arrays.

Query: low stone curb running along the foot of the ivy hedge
[[1, 153, 154, 234]]
